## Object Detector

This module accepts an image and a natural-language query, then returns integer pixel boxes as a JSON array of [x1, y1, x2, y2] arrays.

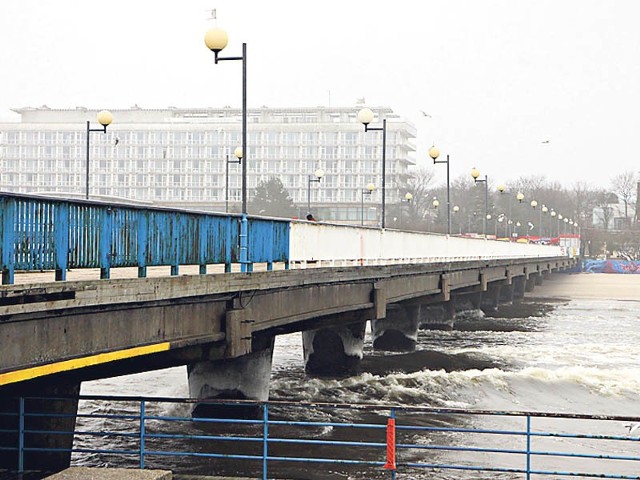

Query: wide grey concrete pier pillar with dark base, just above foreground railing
[[187, 338, 274, 418]]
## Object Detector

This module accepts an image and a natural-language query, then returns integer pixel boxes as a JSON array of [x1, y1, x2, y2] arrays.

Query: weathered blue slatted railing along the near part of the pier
[[0, 193, 290, 284]]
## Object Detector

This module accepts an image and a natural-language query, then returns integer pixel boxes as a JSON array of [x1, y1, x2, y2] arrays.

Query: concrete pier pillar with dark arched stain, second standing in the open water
[[302, 322, 367, 375]]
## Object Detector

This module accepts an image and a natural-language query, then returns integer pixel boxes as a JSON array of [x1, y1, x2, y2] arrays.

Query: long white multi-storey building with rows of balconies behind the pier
[[0, 105, 416, 223]]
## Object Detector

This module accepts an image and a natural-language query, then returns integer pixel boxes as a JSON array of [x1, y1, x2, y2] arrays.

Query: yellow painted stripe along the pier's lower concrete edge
[[0, 342, 171, 385]]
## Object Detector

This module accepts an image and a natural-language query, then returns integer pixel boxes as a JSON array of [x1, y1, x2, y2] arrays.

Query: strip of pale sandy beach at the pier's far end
[[526, 273, 640, 301]]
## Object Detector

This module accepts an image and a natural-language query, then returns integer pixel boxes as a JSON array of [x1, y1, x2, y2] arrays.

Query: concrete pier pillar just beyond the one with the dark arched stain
[[371, 304, 420, 352]]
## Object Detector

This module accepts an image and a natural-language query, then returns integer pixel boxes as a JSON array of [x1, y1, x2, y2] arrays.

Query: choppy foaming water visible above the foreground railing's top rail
[[79, 292, 640, 479]]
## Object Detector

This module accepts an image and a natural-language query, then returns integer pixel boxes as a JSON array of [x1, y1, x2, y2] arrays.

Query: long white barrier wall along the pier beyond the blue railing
[[289, 222, 567, 264]]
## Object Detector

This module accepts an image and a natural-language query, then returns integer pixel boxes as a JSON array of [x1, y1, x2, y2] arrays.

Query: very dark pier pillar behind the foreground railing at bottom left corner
[[0, 380, 80, 473]]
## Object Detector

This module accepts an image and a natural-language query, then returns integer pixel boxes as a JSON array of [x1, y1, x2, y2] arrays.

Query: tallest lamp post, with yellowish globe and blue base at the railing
[[204, 27, 251, 272]]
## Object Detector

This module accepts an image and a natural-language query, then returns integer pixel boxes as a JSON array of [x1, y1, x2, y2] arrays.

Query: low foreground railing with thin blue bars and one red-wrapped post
[[0, 396, 640, 479]]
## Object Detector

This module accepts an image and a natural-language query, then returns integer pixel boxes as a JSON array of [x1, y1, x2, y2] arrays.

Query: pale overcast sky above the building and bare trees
[[0, 0, 640, 186]]
